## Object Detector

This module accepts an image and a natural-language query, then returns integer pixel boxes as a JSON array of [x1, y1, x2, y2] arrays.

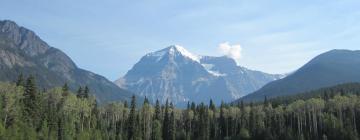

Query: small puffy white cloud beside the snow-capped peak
[[218, 42, 242, 63]]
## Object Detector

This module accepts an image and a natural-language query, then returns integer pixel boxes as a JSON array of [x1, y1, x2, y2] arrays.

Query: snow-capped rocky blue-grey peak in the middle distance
[[115, 45, 281, 105]]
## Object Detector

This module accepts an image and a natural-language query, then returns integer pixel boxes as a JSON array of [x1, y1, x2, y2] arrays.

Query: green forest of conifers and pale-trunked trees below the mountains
[[0, 77, 360, 140]]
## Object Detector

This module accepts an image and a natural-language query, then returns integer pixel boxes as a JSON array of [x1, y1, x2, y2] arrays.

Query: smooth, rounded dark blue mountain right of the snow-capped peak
[[240, 50, 360, 101]]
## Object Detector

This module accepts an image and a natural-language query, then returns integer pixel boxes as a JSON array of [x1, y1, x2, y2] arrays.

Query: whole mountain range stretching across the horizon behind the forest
[[0, 20, 360, 105]]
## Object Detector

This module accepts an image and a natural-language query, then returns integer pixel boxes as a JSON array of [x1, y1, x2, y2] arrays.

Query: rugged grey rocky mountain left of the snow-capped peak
[[0, 20, 132, 102]]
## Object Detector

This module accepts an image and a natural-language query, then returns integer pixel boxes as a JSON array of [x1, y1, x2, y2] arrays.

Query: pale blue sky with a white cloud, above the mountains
[[0, 0, 360, 80]]
